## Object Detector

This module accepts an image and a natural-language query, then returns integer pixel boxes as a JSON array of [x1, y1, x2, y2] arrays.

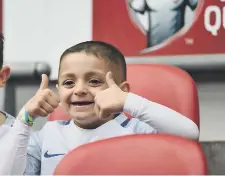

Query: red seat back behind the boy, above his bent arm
[[127, 64, 199, 127]]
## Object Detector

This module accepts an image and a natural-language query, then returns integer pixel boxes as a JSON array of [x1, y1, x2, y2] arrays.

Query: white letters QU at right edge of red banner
[[204, 0, 225, 36]]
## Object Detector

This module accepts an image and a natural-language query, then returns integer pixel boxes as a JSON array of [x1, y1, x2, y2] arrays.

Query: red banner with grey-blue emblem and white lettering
[[93, 0, 225, 56]]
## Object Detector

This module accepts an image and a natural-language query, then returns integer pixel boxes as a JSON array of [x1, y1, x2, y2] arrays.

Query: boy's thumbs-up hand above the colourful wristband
[[24, 74, 59, 117]]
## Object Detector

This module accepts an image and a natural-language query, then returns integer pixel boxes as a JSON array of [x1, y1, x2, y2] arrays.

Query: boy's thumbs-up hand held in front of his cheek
[[95, 72, 128, 119]]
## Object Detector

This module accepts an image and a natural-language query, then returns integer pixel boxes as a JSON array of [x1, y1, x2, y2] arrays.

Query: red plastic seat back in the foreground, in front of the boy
[[54, 134, 207, 175]]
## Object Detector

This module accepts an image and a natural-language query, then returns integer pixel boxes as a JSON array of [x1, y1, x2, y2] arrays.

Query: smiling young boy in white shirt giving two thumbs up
[[0, 41, 199, 175]]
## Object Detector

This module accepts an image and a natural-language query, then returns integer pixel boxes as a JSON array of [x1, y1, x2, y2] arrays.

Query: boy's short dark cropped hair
[[59, 41, 127, 81]]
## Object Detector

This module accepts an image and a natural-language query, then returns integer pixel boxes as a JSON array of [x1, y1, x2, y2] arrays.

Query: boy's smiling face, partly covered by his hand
[[58, 52, 116, 126]]
